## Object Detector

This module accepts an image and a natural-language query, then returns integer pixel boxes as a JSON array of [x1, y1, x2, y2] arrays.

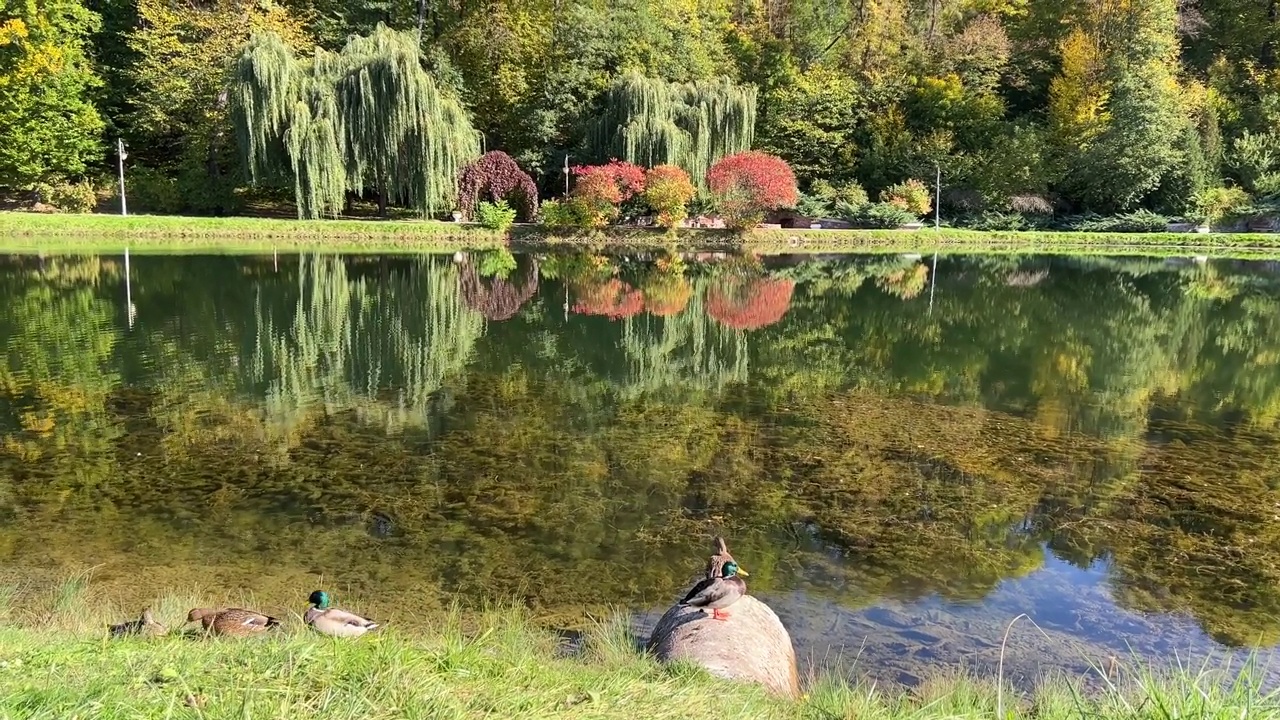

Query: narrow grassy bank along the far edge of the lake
[[0, 207, 1280, 258]]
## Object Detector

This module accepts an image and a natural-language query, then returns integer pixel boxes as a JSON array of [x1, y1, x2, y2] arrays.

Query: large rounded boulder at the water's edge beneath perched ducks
[[648, 596, 800, 698]]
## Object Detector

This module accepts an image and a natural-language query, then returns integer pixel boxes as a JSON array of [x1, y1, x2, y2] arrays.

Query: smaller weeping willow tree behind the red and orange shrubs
[[589, 73, 756, 190]]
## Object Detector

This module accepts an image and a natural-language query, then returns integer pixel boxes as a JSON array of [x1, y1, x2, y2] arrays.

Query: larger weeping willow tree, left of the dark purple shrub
[[230, 24, 480, 218]]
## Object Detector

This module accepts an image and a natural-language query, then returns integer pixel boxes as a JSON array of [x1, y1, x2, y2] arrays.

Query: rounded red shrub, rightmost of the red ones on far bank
[[707, 150, 799, 229]]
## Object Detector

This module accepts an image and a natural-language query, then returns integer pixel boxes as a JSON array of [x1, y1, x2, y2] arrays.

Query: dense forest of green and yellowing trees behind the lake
[[0, 0, 1280, 229]]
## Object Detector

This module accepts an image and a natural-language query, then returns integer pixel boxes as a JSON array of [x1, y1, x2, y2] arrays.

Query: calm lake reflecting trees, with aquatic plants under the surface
[[0, 251, 1280, 683]]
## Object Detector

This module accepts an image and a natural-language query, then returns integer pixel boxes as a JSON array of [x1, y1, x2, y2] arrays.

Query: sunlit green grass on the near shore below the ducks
[[0, 578, 1280, 720]]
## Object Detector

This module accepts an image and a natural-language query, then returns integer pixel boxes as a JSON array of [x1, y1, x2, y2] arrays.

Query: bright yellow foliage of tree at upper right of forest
[[1048, 27, 1110, 146]]
